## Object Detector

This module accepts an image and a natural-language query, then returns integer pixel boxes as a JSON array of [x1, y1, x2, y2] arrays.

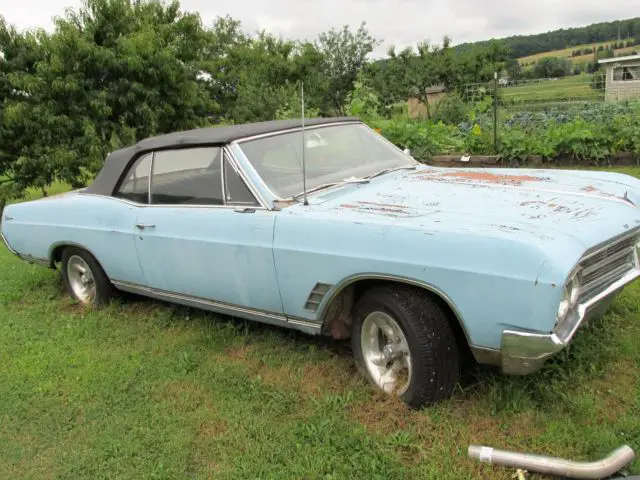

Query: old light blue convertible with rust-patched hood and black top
[[0, 118, 640, 407]]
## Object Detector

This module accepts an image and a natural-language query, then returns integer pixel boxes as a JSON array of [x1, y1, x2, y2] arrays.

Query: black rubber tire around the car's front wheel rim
[[351, 286, 460, 408]]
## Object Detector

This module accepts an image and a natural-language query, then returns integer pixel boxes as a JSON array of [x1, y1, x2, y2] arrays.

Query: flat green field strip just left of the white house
[[500, 74, 604, 104]]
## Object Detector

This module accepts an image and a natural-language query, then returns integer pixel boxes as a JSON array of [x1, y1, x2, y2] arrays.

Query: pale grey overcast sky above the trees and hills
[[5, 0, 640, 54]]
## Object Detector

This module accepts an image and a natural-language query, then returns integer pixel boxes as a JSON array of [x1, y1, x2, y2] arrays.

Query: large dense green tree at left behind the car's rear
[[0, 0, 216, 201]]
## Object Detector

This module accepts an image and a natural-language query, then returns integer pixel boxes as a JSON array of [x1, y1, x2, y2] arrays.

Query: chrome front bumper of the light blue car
[[500, 268, 640, 375]]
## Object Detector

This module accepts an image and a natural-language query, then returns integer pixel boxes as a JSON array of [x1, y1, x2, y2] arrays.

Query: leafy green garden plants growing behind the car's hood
[[372, 101, 640, 165]]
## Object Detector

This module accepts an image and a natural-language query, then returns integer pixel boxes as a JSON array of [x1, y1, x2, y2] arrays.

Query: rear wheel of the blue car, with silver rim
[[61, 247, 113, 306]]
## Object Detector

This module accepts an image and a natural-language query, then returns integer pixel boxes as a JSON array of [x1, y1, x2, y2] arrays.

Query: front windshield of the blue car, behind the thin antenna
[[240, 123, 416, 198]]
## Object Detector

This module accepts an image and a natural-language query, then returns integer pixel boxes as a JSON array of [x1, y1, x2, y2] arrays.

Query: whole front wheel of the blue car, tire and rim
[[351, 287, 460, 408]]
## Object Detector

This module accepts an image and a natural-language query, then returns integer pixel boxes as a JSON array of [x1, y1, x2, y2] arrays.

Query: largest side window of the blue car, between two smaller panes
[[151, 147, 224, 205]]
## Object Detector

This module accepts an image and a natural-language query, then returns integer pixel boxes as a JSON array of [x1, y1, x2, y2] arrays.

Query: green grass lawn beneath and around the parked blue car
[[0, 171, 640, 480]]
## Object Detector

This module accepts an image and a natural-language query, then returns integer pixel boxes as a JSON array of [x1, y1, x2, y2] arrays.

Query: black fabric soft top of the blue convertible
[[83, 117, 358, 195]]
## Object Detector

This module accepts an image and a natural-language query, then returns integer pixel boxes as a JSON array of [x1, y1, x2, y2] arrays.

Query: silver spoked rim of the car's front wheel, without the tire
[[360, 312, 411, 395]]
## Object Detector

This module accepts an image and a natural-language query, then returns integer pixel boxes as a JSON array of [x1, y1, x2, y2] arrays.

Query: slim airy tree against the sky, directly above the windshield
[[316, 22, 379, 114]]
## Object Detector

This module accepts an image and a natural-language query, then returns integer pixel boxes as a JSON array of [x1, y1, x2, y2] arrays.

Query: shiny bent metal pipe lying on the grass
[[469, 445, 636, 479]]
